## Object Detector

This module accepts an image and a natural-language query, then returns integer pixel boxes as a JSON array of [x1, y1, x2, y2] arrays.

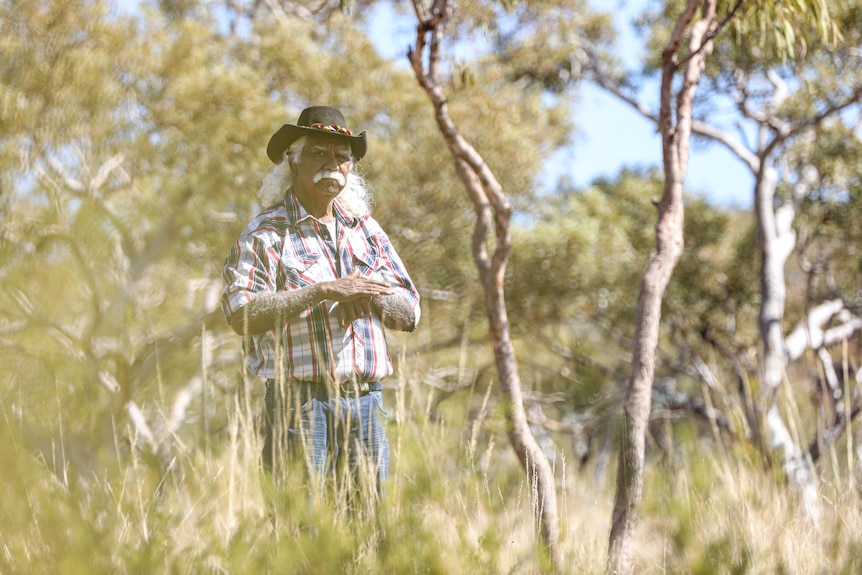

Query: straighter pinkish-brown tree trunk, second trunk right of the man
[[608, 0, 715, 574]]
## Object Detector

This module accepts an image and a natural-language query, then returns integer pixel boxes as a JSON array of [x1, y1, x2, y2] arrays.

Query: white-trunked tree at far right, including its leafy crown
[[699, 4, 862, 500]]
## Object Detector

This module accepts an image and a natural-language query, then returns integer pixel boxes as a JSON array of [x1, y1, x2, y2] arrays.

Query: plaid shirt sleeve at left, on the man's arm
[[221, 235, 276, 322]]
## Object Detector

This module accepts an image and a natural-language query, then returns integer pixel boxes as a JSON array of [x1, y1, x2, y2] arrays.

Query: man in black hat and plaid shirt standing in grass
[[222, 106, 420, 500]]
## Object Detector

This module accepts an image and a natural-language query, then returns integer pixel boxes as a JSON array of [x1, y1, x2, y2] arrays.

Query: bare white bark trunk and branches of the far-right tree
[[593, 53, 862, 508]]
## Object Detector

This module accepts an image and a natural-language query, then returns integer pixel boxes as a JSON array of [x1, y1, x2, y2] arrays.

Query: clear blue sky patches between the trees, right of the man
[[370, 0, 754, 207]]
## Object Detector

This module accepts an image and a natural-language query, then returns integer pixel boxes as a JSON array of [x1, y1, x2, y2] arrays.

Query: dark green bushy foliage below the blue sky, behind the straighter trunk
[[508, 171, 757, 394]]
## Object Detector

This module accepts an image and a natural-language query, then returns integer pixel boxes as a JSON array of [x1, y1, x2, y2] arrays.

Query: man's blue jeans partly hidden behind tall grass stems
[[262, 380, 389, 494]]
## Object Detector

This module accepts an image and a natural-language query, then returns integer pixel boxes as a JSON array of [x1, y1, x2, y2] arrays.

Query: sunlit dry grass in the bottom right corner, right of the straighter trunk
[[638, 428, 862, 574]]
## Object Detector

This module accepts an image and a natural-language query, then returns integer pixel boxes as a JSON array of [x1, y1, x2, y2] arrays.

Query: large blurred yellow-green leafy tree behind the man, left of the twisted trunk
[[0, 0, 480, 474]]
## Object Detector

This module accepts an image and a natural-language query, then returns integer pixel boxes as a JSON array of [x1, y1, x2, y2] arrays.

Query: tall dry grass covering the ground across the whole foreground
[[0, 358, 862, 574]]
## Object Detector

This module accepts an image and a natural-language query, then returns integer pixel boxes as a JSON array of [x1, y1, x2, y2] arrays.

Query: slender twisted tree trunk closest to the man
[[409, 0, 566, 572]]
